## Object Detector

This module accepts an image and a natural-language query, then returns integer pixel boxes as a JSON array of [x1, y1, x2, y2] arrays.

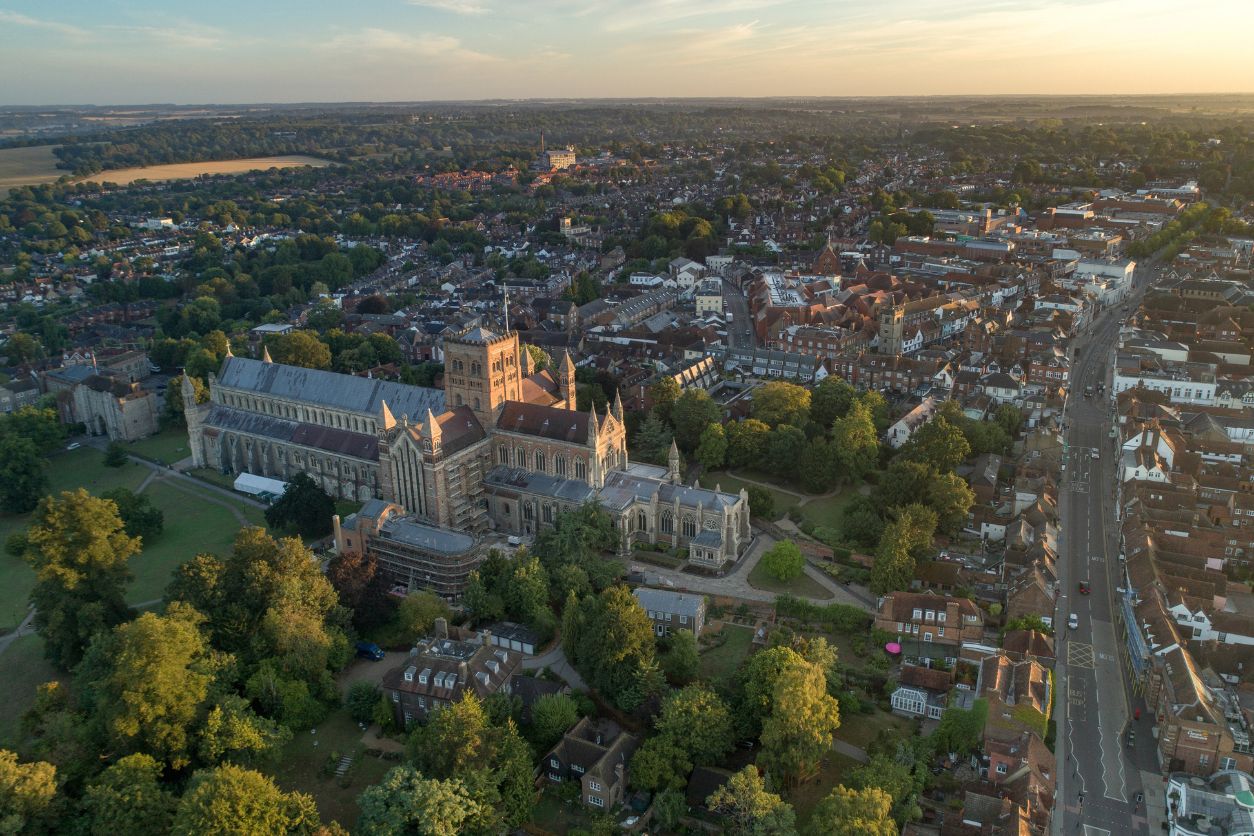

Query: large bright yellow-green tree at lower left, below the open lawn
[[84, 604, 213, 770]]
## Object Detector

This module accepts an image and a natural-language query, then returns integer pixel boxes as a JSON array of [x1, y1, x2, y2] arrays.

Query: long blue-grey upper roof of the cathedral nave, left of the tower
[[218, 357, 444, 420]]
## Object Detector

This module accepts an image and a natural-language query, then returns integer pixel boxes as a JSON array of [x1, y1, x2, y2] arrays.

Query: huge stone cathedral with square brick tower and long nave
[[183, 327, 751, 581]]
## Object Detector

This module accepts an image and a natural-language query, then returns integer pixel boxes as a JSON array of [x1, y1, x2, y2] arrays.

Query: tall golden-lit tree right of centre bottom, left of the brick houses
[[757, 659, 840, 786]]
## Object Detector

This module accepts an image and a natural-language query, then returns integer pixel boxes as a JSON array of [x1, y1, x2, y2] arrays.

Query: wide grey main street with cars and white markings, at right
[[1053, 267, 1156, 836]]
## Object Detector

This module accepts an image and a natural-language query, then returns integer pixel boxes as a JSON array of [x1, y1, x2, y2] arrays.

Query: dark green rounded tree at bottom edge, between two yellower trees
[[83, 753, 177, 836]]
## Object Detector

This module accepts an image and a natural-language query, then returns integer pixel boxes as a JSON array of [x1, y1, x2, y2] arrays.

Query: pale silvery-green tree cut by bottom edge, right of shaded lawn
[[357, 765, 490, 836]]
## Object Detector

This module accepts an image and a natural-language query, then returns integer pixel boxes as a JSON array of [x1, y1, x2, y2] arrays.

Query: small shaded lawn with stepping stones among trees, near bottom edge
[[271, 708, 399, 827]]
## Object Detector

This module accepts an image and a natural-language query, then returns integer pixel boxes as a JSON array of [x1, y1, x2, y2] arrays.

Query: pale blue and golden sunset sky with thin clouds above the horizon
[[0, 0, 1254, 104]]
